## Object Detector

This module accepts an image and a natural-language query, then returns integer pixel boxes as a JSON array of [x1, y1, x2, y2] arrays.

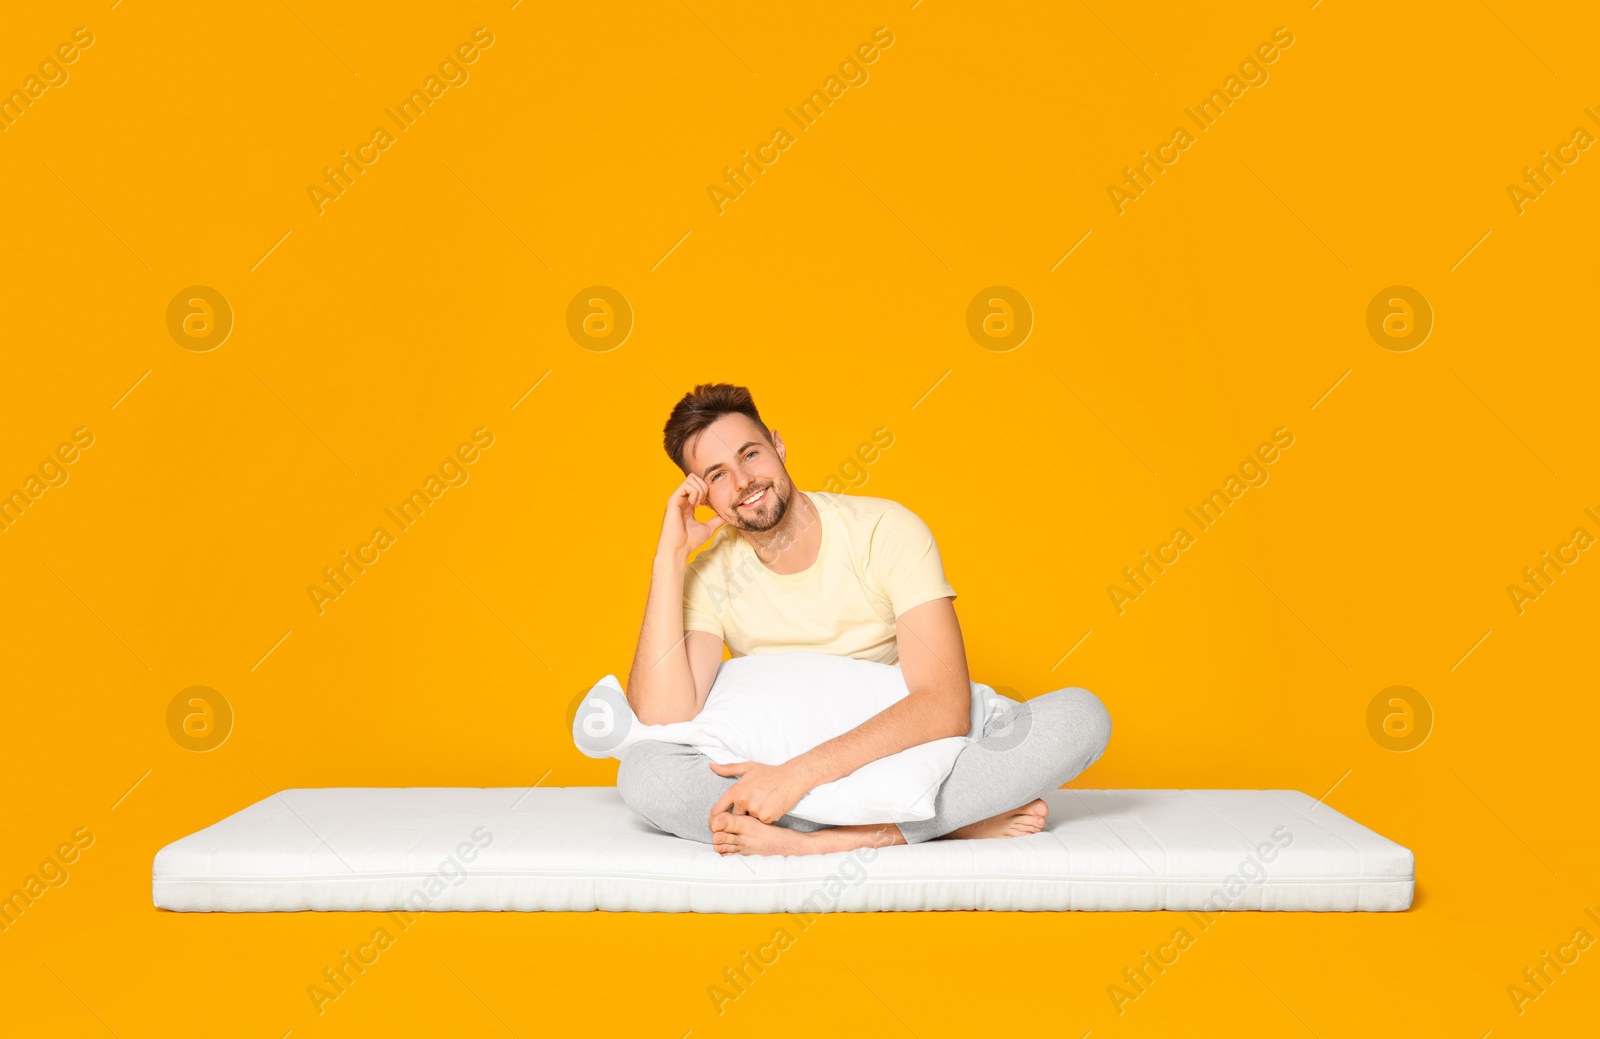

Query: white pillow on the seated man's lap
[[573, 652, 1013, 826]]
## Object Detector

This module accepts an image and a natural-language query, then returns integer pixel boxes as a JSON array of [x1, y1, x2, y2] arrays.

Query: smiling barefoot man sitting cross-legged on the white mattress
[[618, 383, 1110, 855]]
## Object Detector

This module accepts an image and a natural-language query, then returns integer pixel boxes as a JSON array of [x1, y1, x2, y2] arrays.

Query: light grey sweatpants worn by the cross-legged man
[[616, 687, 1110, 844]]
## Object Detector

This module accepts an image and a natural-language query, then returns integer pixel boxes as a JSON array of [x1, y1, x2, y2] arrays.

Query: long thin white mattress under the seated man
[[154, 786, 1413, 913]]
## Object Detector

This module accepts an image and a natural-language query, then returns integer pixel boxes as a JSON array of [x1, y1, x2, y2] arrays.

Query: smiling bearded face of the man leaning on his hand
[[683, 413, 795, 530]]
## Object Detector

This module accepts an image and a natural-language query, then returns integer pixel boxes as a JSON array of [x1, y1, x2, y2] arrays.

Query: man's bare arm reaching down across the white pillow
[[710, 597, 973, 823]]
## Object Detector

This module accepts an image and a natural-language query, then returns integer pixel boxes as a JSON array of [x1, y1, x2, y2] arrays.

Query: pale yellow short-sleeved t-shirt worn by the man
[[683, 490, 955, 664]]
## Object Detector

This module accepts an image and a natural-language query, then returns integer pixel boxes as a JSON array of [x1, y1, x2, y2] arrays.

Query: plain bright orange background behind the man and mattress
[[0, 0, 1600, 1039]]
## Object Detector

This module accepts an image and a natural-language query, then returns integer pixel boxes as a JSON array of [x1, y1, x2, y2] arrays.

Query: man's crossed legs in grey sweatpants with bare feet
[[616, 687, 1110, 855]]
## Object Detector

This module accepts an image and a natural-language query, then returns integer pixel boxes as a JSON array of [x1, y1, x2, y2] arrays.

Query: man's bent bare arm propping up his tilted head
[[627, 474, 722, 725]]
